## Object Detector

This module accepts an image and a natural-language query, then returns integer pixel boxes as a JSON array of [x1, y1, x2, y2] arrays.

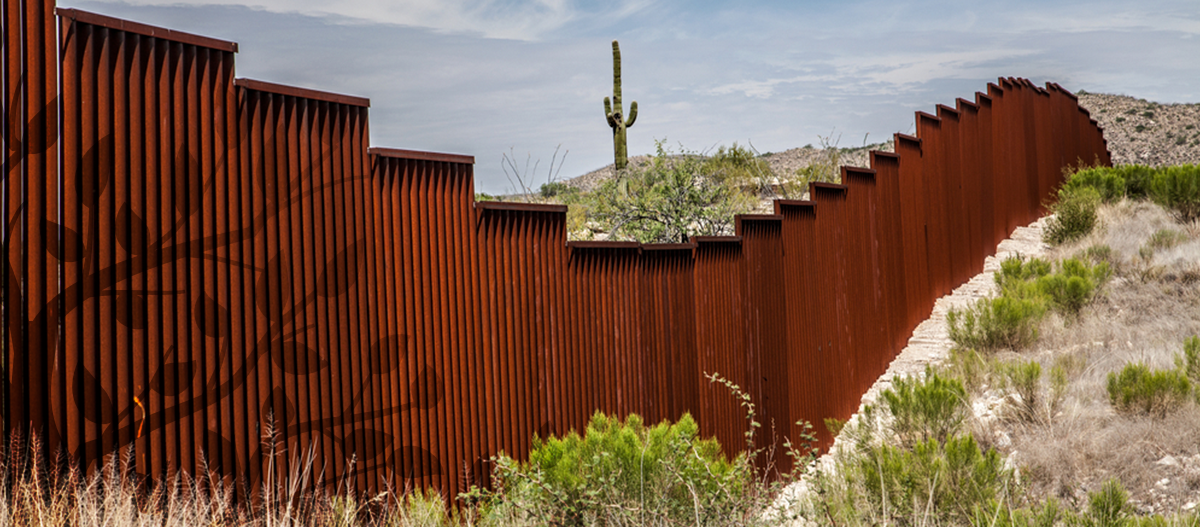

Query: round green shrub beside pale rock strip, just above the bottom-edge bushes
[[881, 366, 967, 447]]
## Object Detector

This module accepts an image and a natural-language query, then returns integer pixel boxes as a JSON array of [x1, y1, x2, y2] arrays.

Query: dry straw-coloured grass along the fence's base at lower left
[[0, 438, 470, 527]]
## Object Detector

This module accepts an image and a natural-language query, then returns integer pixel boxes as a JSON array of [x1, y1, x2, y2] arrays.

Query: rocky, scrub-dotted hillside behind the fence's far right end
[[1079, 91, 1200, 167]]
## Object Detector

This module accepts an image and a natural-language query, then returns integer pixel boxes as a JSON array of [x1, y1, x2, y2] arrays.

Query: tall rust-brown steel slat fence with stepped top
[[0, 0, 1109, 504]]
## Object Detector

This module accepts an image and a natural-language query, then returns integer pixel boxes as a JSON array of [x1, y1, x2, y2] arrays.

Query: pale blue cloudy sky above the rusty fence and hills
[[60, 0, 1200, 192]]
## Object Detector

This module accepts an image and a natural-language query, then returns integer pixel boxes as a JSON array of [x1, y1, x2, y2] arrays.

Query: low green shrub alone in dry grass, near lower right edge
[[1108, 364, 1192, 417]]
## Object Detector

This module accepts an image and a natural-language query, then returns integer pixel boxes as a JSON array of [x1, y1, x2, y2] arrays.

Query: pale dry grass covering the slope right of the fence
[[974, 202, 1200, 513]]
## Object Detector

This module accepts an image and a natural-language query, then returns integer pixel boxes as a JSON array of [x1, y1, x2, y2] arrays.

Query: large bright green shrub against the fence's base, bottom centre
[[496, 412, 750, 525]]
